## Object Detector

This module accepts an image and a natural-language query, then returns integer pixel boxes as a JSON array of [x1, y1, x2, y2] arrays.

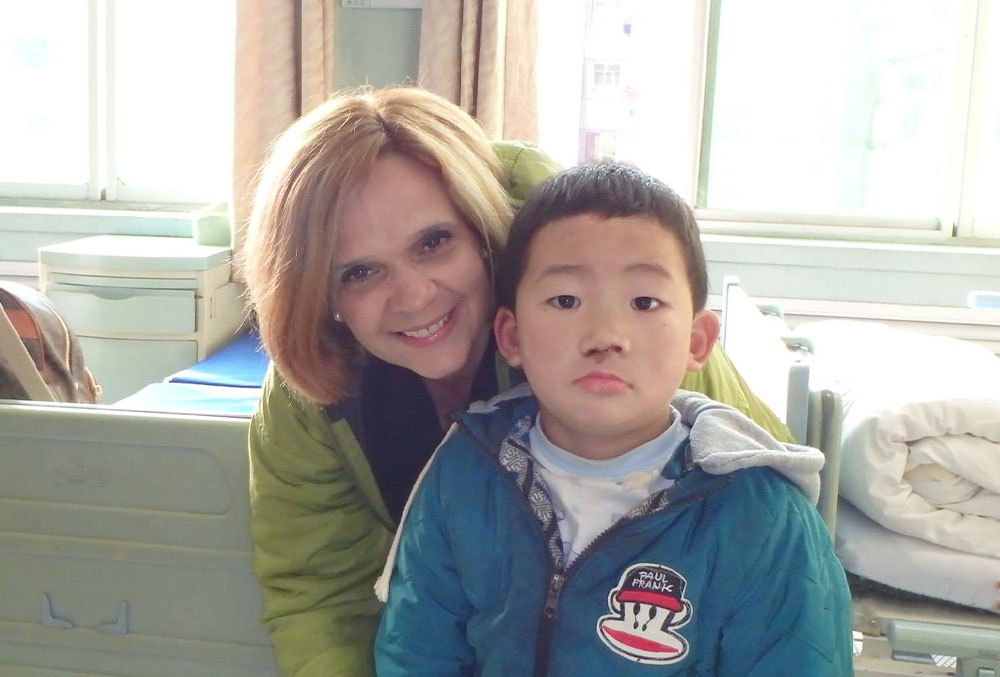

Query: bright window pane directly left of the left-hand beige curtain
[[115, 0, 235, 201]]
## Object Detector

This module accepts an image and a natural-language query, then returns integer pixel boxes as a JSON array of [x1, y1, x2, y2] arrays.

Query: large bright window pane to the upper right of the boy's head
[[703, 0, 965, 217]]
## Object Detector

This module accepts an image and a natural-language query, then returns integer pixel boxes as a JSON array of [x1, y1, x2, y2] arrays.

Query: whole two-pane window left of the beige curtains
[[0, 0, 235, 203]]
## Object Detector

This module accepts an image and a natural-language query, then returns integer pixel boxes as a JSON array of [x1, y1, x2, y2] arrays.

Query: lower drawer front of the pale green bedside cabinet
[[78, 336, 198, 404]]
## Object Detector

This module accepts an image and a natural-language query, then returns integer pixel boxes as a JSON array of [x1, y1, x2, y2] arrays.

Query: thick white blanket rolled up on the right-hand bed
[[798, 321, 1000, 557]]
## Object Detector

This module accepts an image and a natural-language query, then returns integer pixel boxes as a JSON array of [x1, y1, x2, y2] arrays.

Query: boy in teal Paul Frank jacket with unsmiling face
[[375, 164, 851, 676]]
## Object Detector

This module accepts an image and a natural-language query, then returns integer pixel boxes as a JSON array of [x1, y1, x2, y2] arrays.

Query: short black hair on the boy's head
[[496, 162, 708, 312]]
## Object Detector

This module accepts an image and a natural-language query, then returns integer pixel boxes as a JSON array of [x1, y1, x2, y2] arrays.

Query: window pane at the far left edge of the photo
[[0, 0, 89, 185]]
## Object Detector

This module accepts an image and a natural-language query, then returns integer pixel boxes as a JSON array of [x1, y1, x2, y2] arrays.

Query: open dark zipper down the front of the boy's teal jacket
[[456, 418, 729, 677]]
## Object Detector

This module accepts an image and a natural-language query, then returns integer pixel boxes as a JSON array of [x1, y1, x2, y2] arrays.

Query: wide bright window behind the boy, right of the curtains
[[539, 0, 1000, 238]]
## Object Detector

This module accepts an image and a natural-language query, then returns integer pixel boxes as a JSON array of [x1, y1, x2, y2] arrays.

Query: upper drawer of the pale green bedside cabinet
[[45, 284, 195, 334]]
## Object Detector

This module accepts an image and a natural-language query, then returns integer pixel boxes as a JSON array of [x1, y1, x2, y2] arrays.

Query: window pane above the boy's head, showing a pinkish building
[[538, 0, 698, 198]]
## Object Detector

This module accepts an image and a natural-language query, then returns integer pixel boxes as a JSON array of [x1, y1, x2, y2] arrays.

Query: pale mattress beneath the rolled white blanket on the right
[[836, 500, 1000, 614]]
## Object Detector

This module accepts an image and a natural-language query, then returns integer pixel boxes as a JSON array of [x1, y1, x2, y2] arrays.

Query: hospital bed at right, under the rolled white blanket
[[722, 277, 1000, 677]]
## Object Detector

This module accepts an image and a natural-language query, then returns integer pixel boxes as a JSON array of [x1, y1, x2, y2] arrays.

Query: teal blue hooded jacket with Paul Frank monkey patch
[[375, 394, 852, 677]]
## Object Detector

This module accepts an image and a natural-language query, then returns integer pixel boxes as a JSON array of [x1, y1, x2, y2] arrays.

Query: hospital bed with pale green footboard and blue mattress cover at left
[[0, 328, 278, 677]]
